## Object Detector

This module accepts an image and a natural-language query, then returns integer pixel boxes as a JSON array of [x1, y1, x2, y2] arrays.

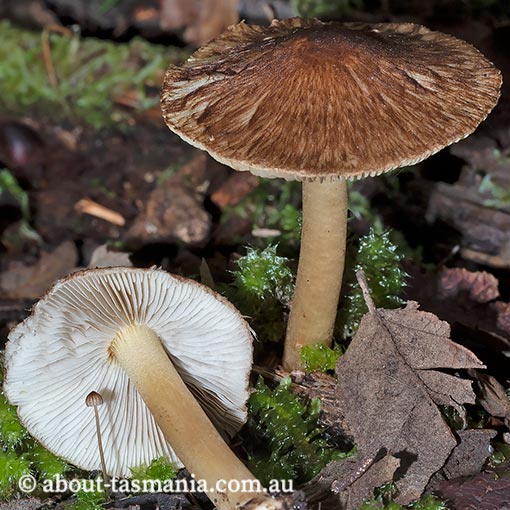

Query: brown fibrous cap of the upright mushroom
[[161, 18, 501, 180]]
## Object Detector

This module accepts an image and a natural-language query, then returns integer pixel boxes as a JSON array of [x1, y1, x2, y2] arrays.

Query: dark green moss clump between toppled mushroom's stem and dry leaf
[[248, 378, 349, 486]]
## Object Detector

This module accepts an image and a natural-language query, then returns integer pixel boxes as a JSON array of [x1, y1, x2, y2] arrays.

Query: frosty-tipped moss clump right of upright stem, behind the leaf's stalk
[[338, 229, 408, 338]]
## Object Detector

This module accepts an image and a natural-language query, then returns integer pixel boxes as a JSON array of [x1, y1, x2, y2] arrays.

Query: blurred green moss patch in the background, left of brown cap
[[0, 21, 185, 127]]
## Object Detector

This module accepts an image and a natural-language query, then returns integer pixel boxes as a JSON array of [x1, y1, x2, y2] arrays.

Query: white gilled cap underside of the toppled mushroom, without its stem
[[4, 267, 252, 476]]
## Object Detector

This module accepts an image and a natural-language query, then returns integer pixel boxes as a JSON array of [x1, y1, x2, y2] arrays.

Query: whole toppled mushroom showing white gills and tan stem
[[4, 267, 273, 510]]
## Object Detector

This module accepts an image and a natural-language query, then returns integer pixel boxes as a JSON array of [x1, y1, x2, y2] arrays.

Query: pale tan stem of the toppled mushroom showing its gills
[[110, 325, 264, 510]]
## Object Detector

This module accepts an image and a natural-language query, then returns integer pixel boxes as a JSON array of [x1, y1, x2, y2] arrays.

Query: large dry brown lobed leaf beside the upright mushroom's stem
[[330, 294, 485, 509]]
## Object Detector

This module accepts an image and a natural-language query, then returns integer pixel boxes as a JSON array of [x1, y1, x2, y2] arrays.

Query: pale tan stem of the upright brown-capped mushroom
[[283, 180, 347, 371]]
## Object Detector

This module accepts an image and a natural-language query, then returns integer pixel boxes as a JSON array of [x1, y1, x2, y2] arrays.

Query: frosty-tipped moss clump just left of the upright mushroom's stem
[[220, 246, 294, 342]]
